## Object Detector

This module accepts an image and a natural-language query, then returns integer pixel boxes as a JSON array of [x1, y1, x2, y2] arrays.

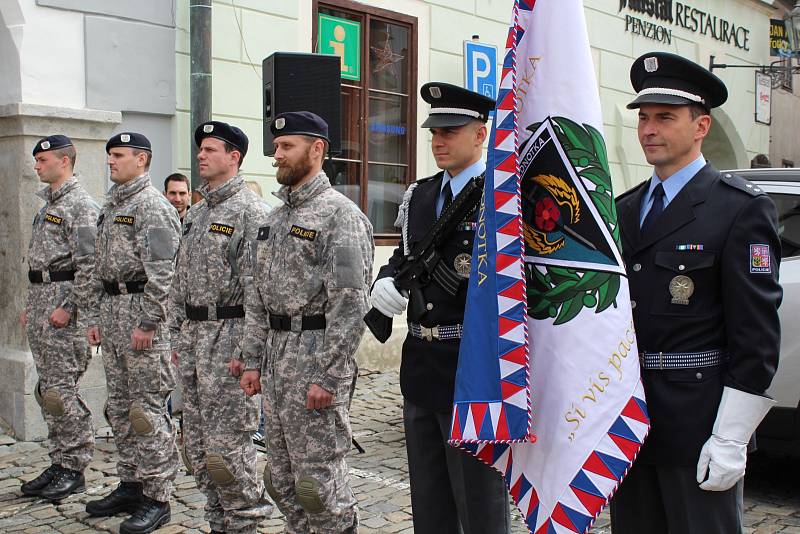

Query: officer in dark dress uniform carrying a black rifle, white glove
[[371, 82, 509, 534]]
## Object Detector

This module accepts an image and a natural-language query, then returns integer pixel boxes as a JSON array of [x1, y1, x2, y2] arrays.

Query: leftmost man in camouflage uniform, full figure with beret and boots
[[22, 135, 99, 500]]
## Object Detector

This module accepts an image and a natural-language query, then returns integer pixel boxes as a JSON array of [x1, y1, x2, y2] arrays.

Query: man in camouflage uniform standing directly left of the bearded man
[[170, 121, 272, 533]]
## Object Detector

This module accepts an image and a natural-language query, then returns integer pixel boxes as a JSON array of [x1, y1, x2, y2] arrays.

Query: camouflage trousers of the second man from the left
[[100, 293, 180, 502]]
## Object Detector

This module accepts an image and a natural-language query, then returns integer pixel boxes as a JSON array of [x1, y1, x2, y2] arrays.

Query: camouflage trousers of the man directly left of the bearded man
[[178, 319, 272, 533]]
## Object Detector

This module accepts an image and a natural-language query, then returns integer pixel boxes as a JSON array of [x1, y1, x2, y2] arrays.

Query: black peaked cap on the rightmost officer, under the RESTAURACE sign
[[628, 52, 728, 110]]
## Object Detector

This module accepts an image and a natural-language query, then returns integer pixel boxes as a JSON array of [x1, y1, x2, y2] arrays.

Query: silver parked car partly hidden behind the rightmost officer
[[728, 168, 800, 455]]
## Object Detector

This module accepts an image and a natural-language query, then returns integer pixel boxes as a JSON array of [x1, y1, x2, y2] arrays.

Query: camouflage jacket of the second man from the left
[[93, 174, 180, 327]]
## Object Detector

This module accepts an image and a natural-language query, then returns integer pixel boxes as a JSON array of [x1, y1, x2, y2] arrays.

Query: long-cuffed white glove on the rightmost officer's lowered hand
[[697, 387, 775, 491]]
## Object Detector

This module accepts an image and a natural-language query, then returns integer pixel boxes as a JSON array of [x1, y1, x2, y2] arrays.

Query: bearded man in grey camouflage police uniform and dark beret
[[241, 112, 374, 534]]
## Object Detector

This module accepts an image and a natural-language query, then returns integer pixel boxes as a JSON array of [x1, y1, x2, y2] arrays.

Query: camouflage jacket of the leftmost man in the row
[[28, 176, 100, 312]]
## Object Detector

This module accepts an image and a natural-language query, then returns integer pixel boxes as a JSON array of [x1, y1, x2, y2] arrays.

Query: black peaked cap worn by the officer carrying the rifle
[[420, 82, 495, 128]]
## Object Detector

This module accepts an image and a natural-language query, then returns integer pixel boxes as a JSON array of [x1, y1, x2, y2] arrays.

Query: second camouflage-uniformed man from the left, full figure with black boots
[[86, 133, 179, 534]]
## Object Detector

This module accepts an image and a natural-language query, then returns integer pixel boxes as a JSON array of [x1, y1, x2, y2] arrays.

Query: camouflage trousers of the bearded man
[[261, 330, 358, 534]]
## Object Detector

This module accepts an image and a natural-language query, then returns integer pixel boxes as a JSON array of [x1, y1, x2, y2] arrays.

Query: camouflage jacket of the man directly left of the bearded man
[[170, 176, 269, 345]]
